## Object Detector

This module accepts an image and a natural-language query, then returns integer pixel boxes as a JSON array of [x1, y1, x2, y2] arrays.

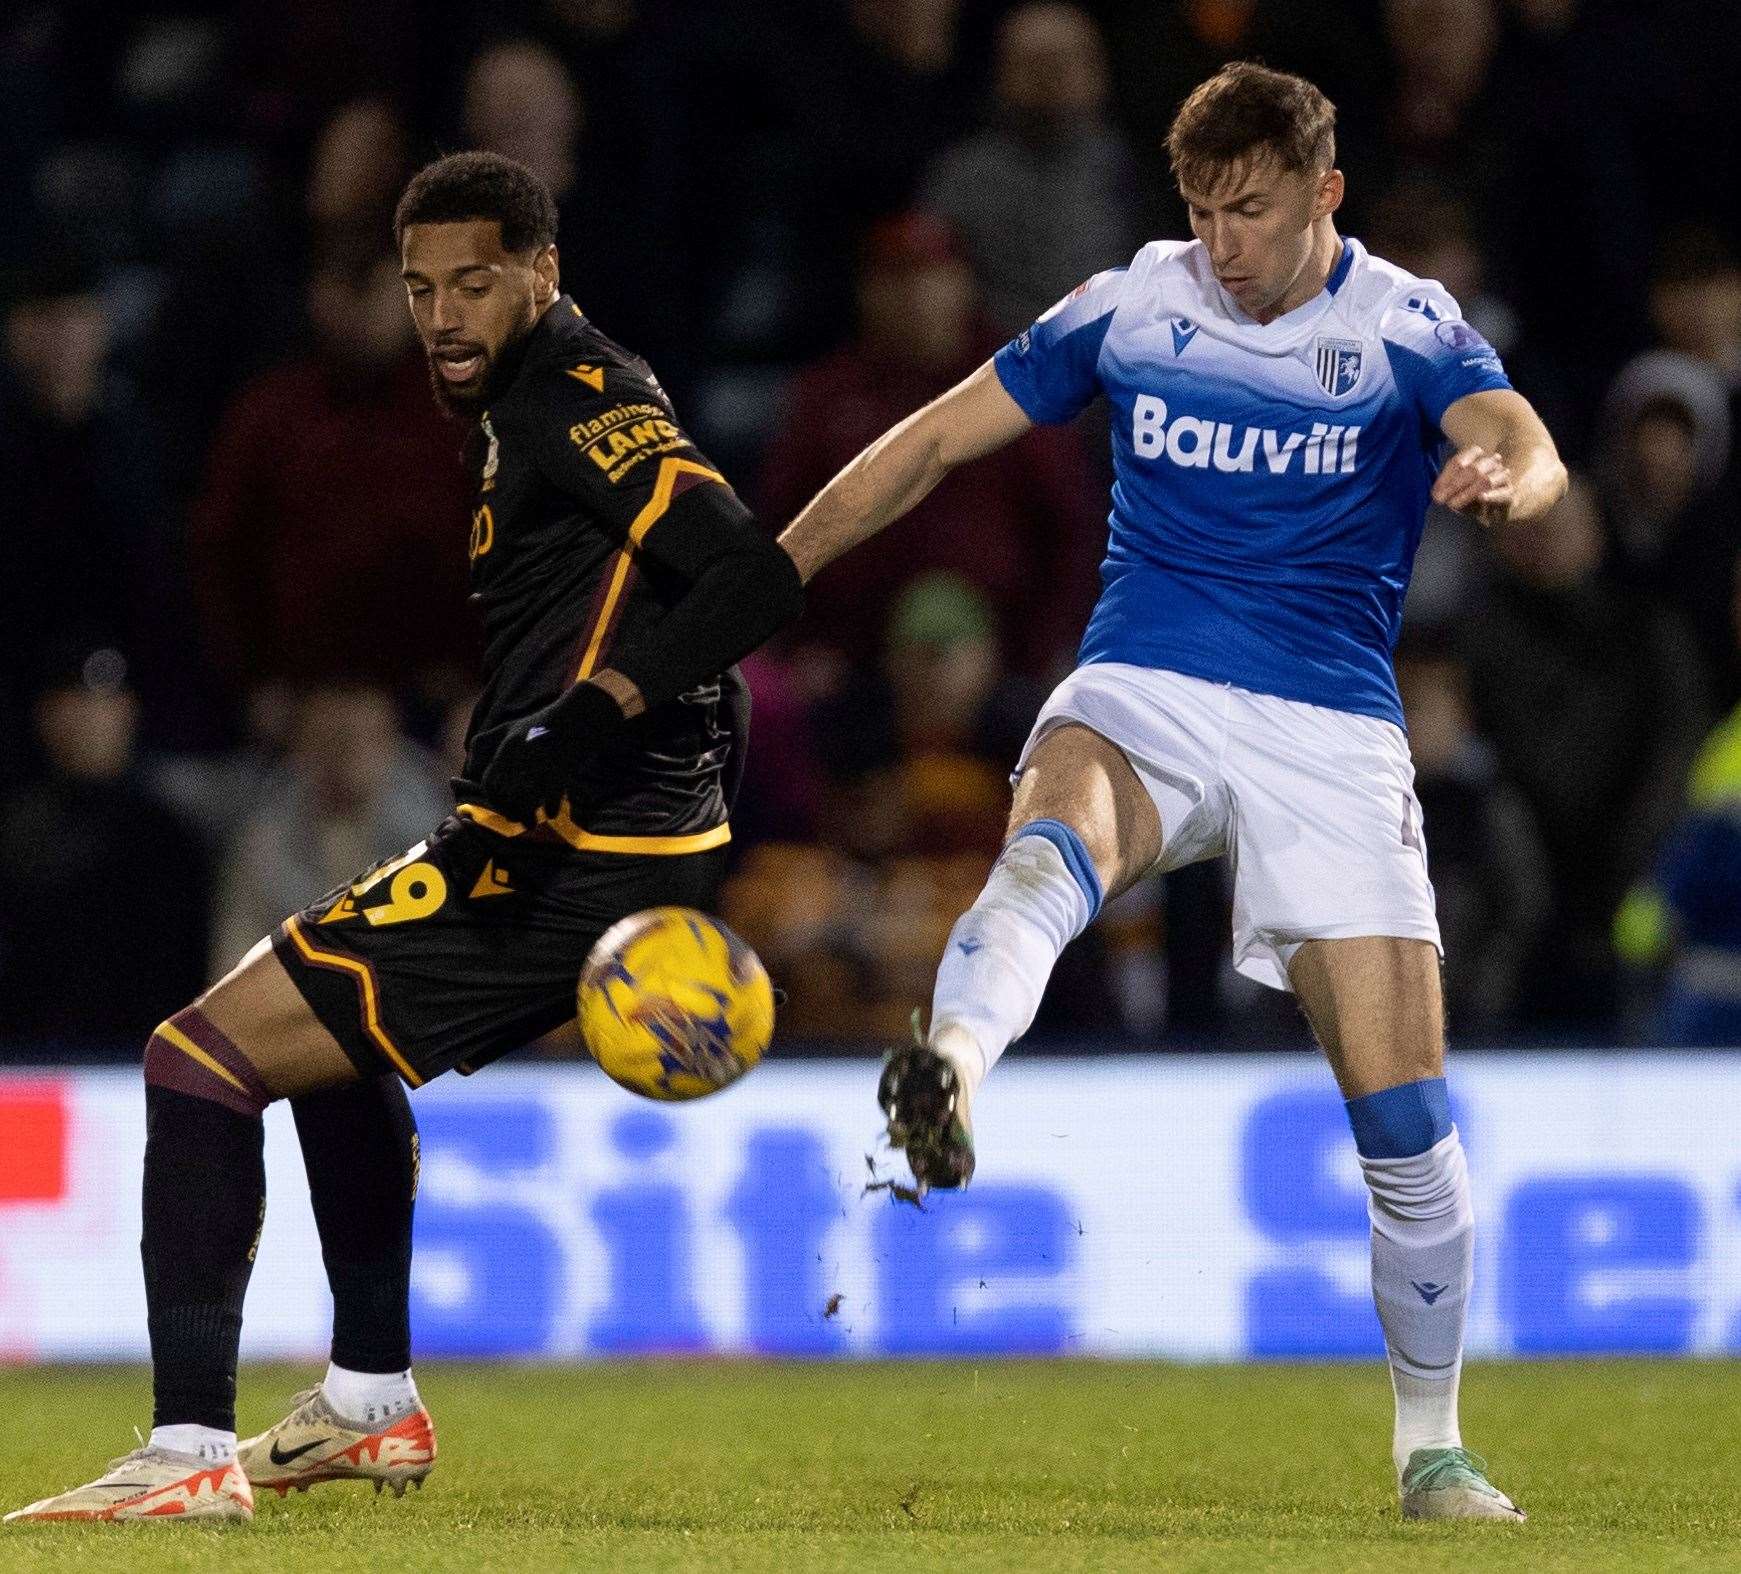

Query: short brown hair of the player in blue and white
[[1166, 61, 1335, 192]]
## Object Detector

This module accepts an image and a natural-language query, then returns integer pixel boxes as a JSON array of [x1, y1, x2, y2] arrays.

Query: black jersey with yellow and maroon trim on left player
[[454, 296, 749, 851]]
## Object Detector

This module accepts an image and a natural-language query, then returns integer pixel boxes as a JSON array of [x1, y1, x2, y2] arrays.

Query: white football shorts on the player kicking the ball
[[1012, 662, 1443, 989]]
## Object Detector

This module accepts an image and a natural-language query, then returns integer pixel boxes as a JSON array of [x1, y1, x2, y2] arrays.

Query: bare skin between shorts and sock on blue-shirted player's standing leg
[[1288, 935, 1445, 1099]]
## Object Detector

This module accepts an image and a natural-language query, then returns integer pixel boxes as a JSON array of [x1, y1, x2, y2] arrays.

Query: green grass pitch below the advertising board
[[0, 1362, 1741, 1574]]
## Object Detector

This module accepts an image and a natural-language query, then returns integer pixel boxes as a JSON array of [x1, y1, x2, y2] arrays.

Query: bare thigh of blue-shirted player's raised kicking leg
[[1010, 723, 1161, 898]]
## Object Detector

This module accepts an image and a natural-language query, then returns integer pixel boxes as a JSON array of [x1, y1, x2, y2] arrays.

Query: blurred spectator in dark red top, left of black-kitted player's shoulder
[[192, 242, 477, 713]]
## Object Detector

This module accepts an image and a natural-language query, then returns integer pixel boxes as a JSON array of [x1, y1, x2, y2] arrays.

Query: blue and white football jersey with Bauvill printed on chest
[[994, 240, 1511, 726]]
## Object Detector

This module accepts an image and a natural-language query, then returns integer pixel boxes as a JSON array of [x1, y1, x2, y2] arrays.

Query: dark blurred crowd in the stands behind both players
[[0, 0, 1741, 1060]]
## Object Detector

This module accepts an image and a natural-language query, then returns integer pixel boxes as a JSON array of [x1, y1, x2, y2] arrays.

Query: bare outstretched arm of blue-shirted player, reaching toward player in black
[[780, 360, 1034, 583]]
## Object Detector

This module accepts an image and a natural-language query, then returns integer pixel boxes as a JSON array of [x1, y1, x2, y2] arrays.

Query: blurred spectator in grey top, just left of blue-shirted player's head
[[919, 0, 1139, 334]]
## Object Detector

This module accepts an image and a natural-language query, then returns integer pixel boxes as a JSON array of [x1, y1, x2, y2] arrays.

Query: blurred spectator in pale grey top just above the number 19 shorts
[[211, 684, 453, 977]]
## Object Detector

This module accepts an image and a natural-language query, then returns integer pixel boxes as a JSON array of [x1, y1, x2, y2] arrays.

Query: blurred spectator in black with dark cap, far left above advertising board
[[0, 646, 209, 1055]]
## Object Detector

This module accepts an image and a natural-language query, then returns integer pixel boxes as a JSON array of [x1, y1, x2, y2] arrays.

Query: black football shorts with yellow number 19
[[272, 815, 726, 1088]]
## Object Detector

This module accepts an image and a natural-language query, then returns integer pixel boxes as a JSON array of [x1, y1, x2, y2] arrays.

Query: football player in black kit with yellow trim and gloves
[[7, 153, 803, 1520]]
